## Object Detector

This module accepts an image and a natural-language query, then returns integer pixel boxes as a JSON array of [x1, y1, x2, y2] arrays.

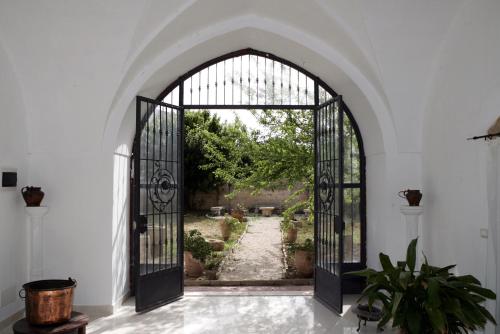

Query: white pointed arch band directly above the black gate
[[104, 15, 397, 158]]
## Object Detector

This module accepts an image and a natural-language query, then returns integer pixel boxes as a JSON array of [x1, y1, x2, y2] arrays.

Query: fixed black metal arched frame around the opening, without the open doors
[[131, 48, 366, 314]]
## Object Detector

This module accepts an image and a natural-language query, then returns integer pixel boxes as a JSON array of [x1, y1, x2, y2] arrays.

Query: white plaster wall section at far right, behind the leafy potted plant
[[423, 0, 500, 306]]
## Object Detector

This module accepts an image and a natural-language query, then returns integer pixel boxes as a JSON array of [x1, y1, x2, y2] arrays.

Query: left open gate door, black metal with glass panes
[[133, 96, 184, 312]]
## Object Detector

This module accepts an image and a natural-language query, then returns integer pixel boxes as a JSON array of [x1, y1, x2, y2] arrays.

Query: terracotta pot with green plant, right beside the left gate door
[[184, 230, 212, 277]]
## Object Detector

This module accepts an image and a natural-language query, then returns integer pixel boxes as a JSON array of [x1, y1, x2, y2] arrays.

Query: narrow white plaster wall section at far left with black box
[[0, 43, 29, 321]]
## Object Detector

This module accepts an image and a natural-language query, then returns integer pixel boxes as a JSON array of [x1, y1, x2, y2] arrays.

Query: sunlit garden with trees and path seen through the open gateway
[[184, 110, 314, 285]]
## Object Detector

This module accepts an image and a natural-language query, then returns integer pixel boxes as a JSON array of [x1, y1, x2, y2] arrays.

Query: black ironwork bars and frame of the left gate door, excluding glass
[[131, 96, 184, 312]]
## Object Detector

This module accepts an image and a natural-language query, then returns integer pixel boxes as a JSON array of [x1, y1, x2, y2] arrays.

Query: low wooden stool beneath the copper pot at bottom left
[[12, 312, 89, 334]]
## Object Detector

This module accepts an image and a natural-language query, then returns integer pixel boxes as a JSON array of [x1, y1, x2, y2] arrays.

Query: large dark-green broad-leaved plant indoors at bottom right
[[348, 239, 496, 334]]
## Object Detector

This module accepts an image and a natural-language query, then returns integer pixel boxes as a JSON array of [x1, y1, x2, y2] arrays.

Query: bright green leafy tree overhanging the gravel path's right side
[[202, 110, 314, 216]]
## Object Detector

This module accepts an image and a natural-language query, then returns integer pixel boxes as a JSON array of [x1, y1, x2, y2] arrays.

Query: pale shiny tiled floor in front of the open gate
[[87, 292, 390, 334]]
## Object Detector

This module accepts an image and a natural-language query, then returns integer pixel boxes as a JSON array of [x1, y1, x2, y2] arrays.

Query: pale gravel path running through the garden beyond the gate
[[219, 217, 283, 281]]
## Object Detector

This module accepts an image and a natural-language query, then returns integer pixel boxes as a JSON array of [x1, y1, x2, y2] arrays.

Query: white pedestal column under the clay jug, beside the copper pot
[[26, 206, 49, 281]]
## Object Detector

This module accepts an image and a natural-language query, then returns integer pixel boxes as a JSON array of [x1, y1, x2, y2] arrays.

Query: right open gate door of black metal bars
[[314, 96, 344, 313]]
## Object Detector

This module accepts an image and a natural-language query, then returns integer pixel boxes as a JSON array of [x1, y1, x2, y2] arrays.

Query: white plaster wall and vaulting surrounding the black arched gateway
[[0, 0, 494, 320]]
